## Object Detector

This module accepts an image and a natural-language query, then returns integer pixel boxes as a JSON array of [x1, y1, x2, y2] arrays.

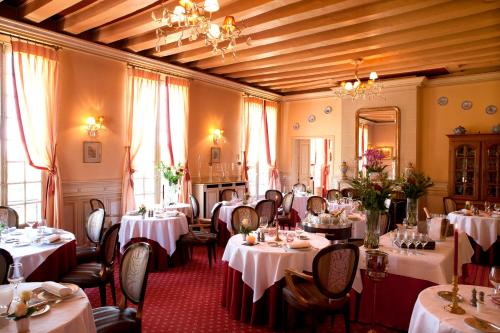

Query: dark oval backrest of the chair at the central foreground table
[[313, 243, 359, 299]]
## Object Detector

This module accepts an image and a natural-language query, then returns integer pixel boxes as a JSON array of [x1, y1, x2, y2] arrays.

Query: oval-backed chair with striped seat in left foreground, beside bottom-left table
[[92, 242, 152, 333]]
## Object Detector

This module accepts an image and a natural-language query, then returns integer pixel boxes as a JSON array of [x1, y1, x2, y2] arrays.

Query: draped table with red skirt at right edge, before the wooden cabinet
[[447, 210, 500, 266]]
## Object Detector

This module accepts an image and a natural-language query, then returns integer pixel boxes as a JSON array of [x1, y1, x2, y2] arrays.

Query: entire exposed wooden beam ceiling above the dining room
[[0, 0, 500, 94]]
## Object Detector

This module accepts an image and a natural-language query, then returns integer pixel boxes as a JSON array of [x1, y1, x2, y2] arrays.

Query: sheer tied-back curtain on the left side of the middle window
[[122, 68, 160, 214]]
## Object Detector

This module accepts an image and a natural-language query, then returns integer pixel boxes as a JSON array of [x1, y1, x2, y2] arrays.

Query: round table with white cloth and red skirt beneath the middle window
[[118, 211, 189, 271]]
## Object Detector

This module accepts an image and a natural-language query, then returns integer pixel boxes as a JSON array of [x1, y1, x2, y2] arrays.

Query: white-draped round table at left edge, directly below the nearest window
[[0, 227, 77, 282]]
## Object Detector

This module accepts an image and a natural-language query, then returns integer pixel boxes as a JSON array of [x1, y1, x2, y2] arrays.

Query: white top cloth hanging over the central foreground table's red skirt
[[222, 234, 330, 303]]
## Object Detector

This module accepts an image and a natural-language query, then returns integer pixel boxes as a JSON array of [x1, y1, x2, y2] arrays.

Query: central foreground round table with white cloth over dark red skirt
[[221, 231, 330, 328]]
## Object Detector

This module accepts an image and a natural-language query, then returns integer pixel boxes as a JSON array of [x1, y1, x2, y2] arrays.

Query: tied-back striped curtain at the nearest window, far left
[[12, 40, 63, 228]]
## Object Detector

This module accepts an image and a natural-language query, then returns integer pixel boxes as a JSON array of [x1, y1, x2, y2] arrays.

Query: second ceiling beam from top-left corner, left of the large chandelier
[[61, 0, 157, 34]]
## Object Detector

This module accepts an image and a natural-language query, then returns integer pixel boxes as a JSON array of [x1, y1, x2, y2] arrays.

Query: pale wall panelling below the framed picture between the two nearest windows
[[62, 179, 122, 244]]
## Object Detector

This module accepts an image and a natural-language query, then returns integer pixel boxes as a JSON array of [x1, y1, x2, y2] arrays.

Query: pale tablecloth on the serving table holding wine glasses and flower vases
[[353, 232, 474, 292]]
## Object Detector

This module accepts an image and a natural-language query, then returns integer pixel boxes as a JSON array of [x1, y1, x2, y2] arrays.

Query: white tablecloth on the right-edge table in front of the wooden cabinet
[[448, 212, 500, 251]]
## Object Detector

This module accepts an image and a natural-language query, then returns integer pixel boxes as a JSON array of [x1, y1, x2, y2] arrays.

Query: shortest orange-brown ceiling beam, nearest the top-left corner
[[21, 0, 81, 23]]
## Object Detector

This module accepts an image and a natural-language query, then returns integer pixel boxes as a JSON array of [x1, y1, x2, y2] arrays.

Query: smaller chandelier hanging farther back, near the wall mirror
[[331, 59, 383, 100]]
